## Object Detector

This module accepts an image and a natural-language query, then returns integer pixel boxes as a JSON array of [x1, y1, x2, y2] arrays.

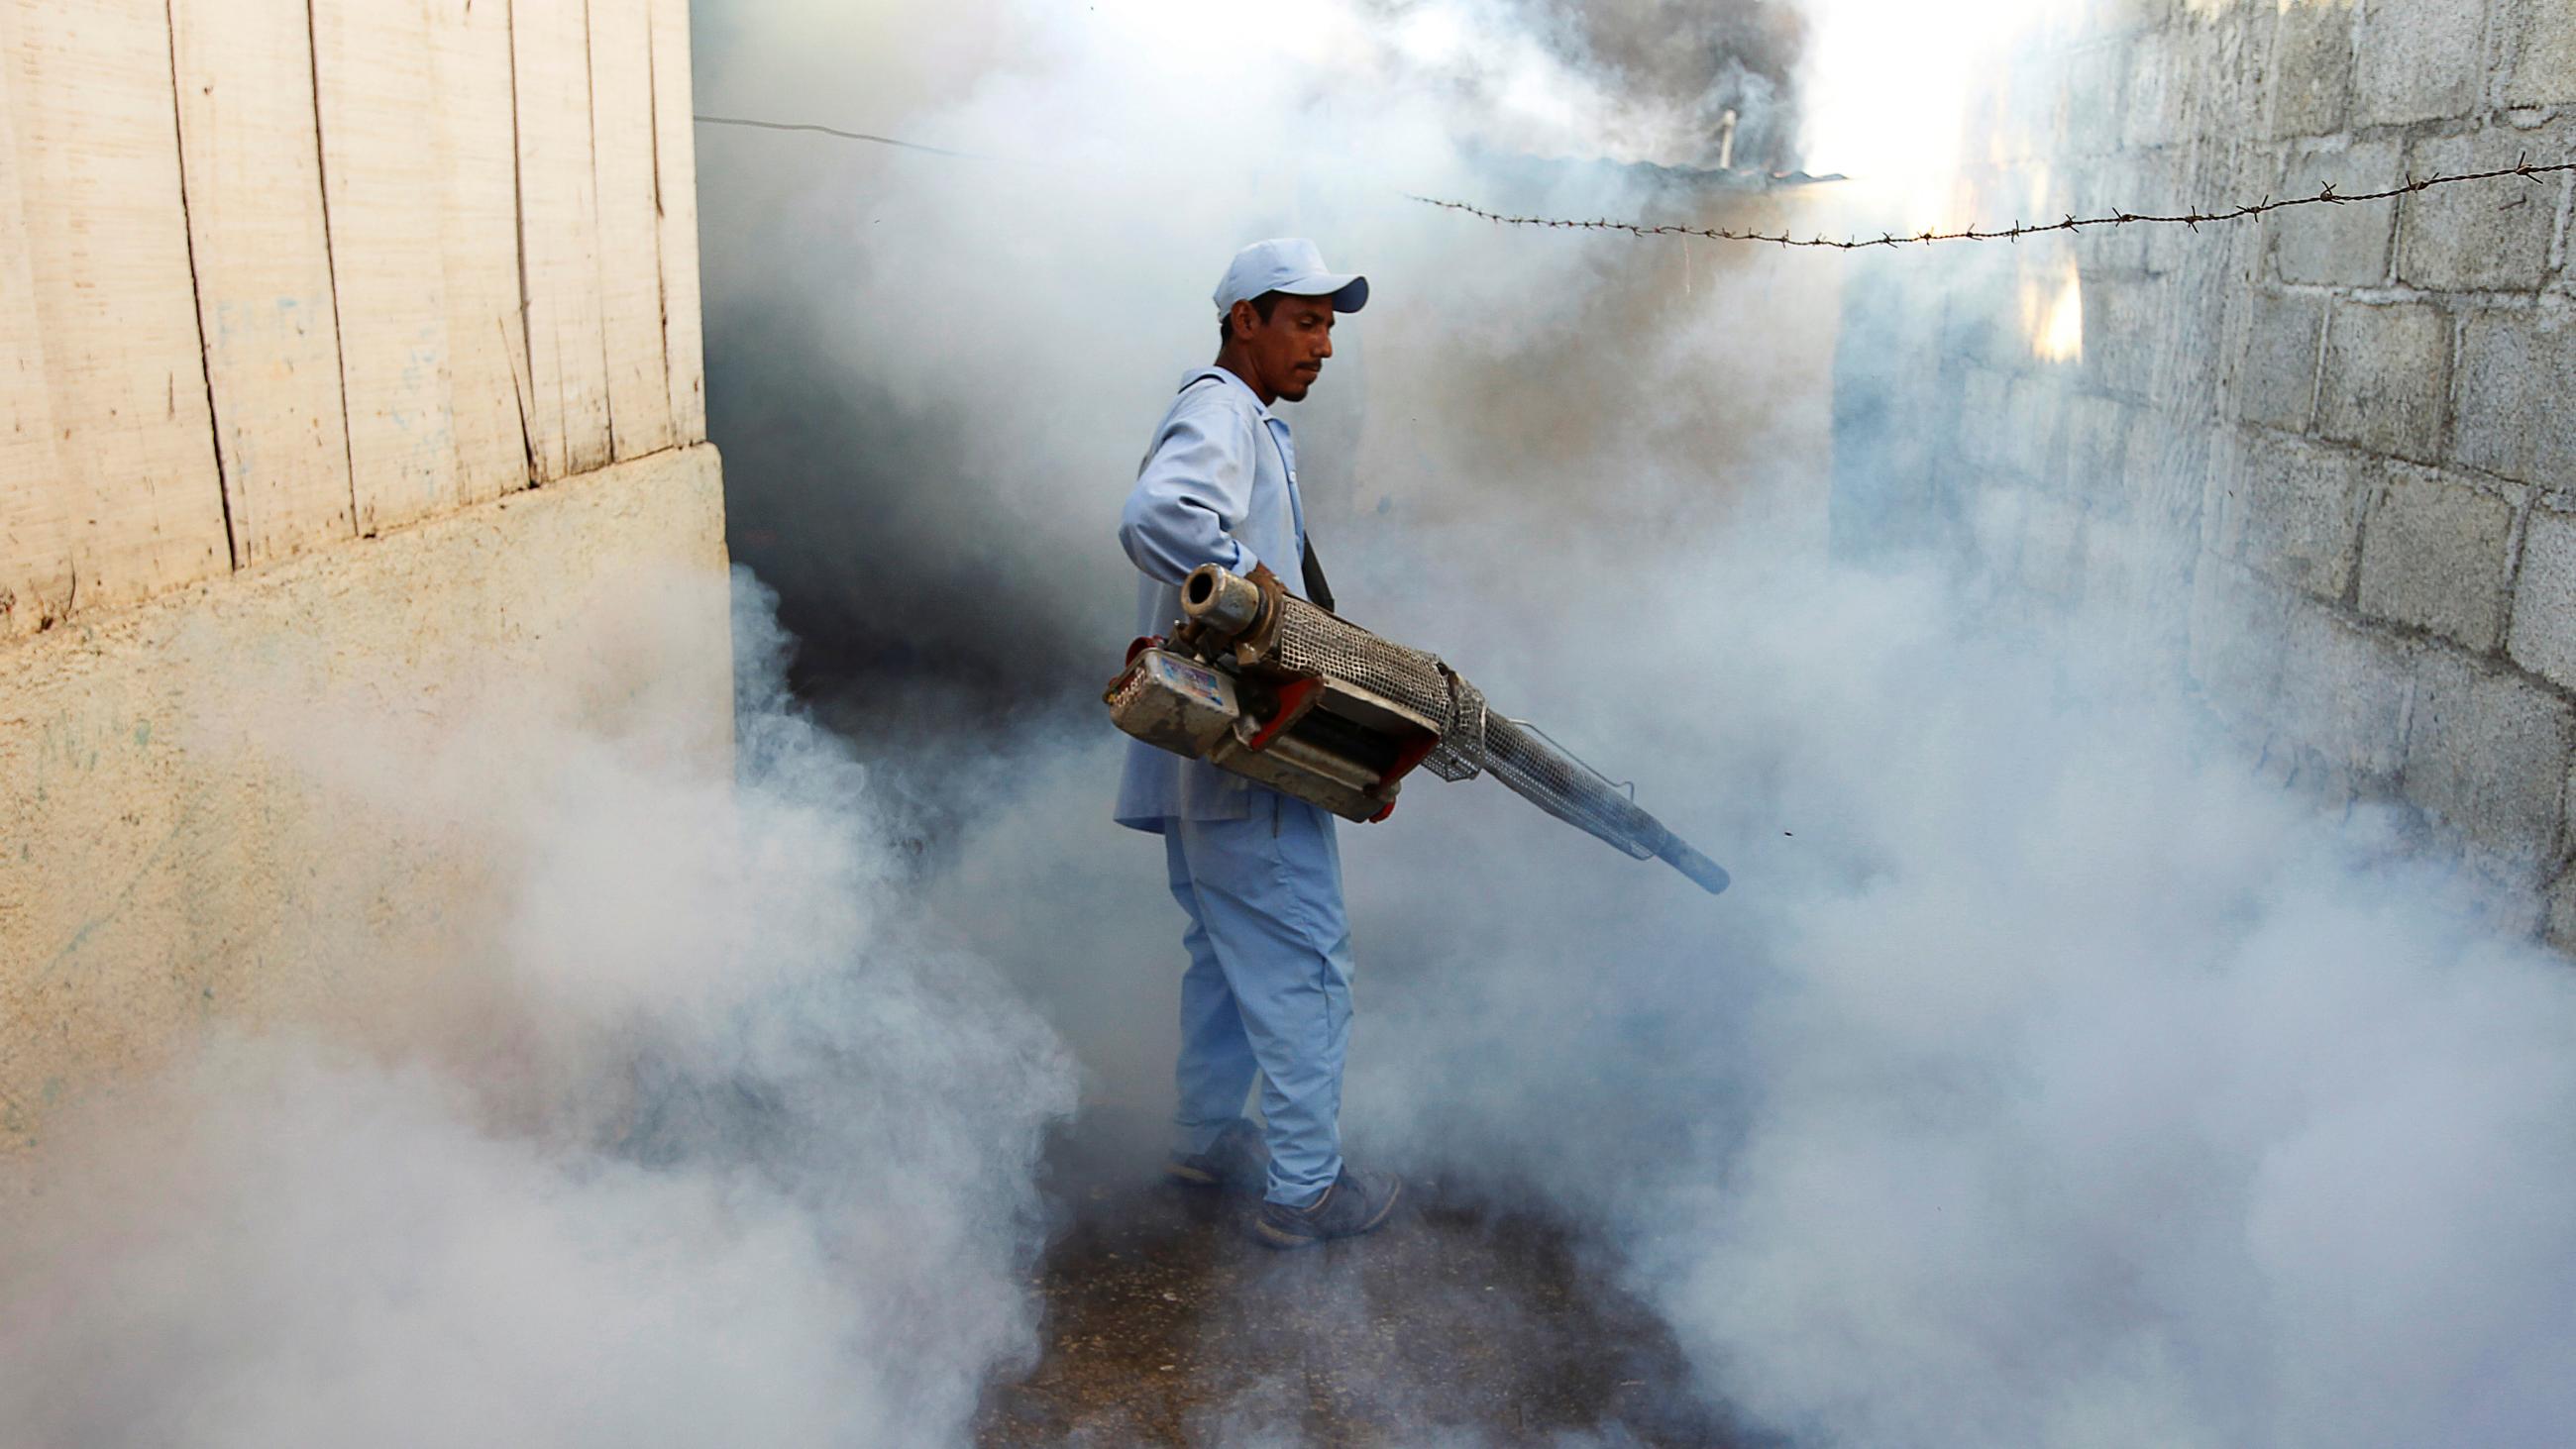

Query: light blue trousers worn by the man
[[1162, 790, 1349, 1207]]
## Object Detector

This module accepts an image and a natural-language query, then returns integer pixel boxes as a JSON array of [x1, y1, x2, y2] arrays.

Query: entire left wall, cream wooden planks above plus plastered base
[[0, 0, 731, 1143]]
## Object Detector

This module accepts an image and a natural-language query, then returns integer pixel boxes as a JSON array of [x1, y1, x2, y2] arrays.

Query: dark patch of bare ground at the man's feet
[[979, 1140, 1752, 1446]]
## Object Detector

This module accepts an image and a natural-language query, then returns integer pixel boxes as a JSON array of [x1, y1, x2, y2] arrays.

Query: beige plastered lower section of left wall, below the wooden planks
[[0, 446, 731, 1145]]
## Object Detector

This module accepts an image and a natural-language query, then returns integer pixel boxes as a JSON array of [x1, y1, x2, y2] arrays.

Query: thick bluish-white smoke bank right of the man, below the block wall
[[1349, 551, 2576, 1446]]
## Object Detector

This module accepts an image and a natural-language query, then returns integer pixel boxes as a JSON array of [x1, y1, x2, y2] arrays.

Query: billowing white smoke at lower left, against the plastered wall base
[[0, 579, 1072, 1446]]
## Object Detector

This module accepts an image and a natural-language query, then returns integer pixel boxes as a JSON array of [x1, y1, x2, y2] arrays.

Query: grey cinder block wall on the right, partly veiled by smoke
[[1837, 0, 2576, 939]]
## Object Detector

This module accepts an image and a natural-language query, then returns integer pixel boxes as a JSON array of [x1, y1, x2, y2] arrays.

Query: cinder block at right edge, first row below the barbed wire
[[2452, 301, 2576, 486]]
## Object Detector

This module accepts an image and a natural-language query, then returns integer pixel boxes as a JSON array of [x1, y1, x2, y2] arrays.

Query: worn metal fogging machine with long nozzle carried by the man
[[1103, 564, 1726, 895]]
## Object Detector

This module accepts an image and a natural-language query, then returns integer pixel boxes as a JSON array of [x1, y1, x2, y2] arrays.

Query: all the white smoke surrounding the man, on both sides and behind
[[20, 3, 2576, 1446]]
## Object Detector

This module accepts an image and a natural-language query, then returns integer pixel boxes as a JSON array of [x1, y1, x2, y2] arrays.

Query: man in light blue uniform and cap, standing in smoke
[[1118, 240, 1404, 1248]]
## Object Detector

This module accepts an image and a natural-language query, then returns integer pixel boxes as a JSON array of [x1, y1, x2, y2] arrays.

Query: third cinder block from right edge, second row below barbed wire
[[2202, 433, 2380, 599]]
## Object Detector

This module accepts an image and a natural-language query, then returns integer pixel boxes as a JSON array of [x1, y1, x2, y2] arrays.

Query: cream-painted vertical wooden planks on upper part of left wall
[[0, 0, 705, 638]]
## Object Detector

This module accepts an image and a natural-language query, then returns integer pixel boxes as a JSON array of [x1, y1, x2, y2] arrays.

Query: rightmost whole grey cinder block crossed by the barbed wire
[[2399, 126, 2566, 291]]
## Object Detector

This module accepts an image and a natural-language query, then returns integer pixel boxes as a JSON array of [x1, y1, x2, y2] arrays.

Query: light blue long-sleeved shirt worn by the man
[[1118, 368, 1306, 834]]
